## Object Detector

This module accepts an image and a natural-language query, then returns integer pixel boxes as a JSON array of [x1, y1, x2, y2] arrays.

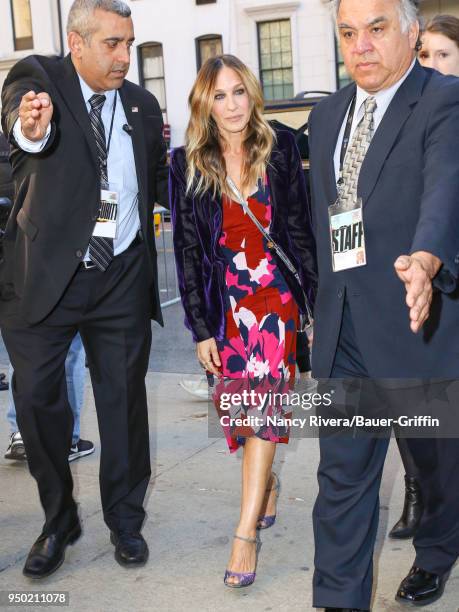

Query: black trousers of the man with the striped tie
[[2, 241, 152, 534]]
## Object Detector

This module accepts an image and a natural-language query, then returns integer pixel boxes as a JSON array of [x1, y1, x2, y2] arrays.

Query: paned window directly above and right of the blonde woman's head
[[258, 19, 293, 100]]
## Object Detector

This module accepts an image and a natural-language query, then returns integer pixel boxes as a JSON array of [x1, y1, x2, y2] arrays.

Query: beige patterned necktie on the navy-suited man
[[340, 96, 377, 208]]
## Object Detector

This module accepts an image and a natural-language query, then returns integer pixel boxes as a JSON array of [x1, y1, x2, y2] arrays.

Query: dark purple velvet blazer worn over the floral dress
[[169, 130, 317, 342]]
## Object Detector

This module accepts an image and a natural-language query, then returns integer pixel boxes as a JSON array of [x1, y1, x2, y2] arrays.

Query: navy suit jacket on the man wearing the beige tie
[[309, 63, 459, 378]]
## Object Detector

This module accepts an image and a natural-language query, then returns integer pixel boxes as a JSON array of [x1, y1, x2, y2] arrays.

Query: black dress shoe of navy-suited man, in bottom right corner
[[395, 565, 449, 606]]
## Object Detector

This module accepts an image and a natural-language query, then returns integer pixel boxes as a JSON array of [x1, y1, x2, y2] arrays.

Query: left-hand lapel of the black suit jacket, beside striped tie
[[54, 55, 99, 169]]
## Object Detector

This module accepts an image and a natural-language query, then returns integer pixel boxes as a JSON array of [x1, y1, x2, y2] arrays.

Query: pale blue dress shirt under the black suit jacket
[[13, 76, 140, 261]]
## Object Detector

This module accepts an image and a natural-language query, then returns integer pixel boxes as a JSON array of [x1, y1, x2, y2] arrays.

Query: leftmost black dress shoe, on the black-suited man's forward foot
[[22, 521, 81, 579]]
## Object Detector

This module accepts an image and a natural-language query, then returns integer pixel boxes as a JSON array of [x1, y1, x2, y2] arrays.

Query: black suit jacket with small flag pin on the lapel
[[0, 55, 168, 323]]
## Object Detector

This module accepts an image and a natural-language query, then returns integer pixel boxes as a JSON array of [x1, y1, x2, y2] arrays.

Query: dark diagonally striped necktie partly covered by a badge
[[89, 94, 113, 272]]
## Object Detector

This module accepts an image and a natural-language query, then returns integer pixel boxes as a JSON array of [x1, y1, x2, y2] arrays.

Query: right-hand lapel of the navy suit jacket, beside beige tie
[[358, 62, 426, 206]]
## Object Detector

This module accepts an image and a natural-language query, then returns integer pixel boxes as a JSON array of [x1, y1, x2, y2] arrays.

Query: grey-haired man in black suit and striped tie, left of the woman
[[0, 0, 167, 578]]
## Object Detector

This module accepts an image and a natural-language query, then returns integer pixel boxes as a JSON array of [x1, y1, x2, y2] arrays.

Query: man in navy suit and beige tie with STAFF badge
[[310, 0, 459, 610]]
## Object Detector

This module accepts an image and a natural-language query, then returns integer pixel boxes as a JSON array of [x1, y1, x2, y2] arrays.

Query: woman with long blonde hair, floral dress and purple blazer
[[170, 55, 316, 587]]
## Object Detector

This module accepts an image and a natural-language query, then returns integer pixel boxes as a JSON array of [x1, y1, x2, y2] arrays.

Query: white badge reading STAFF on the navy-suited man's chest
[[328, 198, 367, 272]]
